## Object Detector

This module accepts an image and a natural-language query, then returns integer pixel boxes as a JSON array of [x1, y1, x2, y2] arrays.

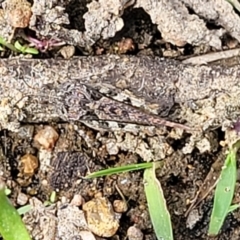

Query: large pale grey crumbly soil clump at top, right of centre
[[134, 0, 221, 49]]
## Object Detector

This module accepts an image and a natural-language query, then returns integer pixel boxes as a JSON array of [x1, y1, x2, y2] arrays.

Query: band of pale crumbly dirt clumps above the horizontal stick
[[0, 0, 240, 57]]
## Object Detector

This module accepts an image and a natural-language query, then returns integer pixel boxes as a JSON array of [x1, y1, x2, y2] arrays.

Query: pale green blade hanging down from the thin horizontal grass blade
[[144, 163, 173, 240]]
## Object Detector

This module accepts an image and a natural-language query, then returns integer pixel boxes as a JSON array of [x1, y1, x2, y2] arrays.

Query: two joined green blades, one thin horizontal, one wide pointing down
[[86, 162, 173, 240]]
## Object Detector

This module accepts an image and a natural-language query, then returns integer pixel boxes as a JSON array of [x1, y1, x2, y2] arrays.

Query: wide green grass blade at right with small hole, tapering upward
[[208, 149, 237, 236]]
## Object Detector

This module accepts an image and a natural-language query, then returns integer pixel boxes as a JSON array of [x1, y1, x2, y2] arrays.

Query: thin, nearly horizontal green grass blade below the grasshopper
[[85, 162, 153, 179]]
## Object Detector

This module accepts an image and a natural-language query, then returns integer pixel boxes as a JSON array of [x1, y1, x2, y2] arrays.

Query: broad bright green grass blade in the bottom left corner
[[0, 184, 31, 240]]
